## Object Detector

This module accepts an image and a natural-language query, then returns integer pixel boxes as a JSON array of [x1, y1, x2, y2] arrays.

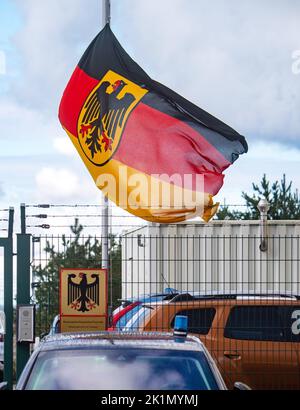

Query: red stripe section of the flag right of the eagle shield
[[114, 103, 231, 195]]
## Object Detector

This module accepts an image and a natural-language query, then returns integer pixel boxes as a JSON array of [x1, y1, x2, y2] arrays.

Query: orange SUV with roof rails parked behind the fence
[[123, 294, 300, 389]]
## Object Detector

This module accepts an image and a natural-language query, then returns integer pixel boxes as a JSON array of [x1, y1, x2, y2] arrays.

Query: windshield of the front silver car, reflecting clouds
[[25, 347, 218, 390]]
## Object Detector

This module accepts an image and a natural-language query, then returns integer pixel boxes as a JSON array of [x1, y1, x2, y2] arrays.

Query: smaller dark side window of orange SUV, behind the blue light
[[171, 308, 216, 335]]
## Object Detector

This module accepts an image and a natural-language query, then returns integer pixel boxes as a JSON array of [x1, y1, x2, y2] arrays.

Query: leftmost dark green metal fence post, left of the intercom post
[[0, 208, 14, 389]]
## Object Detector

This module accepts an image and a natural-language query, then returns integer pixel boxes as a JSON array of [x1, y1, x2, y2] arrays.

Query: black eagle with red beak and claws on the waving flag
[[79, 80, 135, 159]]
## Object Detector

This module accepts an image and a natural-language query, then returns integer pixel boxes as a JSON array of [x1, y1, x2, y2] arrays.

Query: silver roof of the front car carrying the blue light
[[39, 332, 205, 351]]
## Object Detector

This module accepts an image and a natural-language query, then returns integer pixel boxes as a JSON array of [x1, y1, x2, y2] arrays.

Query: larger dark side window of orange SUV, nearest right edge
[[224, 306, 291, 341]]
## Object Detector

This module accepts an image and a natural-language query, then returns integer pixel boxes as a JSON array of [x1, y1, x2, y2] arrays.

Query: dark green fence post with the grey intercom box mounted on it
[[16, 204, 31, 380]]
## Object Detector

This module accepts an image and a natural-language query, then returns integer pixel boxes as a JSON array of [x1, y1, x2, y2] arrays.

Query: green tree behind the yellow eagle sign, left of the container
[[34, 219, 121, 333]]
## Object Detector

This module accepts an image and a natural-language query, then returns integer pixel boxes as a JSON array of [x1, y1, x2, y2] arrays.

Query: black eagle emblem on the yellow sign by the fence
[[68, 273, 99, 312]]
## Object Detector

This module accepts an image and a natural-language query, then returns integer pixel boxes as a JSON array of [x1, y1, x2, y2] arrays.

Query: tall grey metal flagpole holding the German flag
[[102, 0, 112, 320]]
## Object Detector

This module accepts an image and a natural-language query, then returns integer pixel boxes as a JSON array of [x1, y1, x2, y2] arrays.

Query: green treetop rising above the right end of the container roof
[[217, 174, 300, 220]]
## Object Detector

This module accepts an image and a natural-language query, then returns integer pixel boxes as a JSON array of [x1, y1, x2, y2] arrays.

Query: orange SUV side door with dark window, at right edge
[[219, 305, 299, 389]]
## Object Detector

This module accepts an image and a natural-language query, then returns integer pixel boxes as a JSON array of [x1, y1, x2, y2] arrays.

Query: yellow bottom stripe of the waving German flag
[[66, 130, 218, 223]]
